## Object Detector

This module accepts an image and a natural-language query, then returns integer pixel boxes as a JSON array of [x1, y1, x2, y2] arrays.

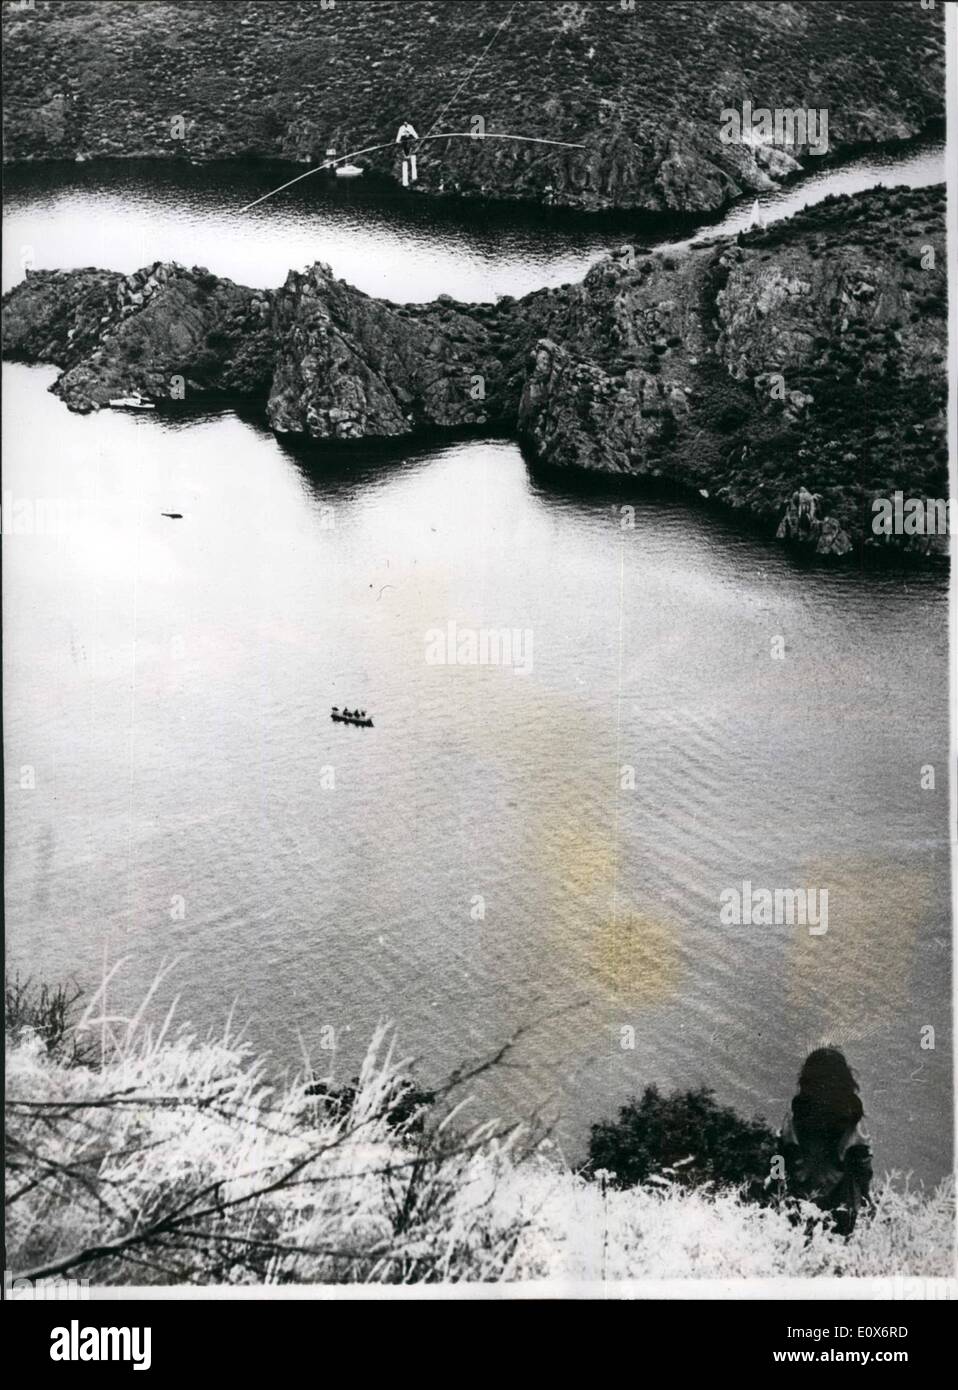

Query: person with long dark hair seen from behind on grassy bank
[[781, 1047, 872, 1236]]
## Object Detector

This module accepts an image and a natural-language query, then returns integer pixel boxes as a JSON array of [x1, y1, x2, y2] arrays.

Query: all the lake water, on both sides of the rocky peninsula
[[3, 141, 951, 1180]]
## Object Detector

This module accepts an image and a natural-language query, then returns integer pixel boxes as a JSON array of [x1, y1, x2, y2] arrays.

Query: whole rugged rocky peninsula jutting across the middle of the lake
[[4, 188, 948, 556]]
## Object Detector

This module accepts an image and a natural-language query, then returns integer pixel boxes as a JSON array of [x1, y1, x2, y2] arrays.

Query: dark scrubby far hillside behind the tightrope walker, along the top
[[3, 0, 944, 213]]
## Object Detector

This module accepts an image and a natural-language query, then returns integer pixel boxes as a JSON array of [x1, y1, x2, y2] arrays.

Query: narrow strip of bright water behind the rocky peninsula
[[4, 142, 944, 302]]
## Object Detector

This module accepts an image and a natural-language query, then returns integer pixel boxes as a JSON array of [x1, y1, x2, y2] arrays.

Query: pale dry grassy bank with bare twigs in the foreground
[[7, 973, 954, 1284]]
